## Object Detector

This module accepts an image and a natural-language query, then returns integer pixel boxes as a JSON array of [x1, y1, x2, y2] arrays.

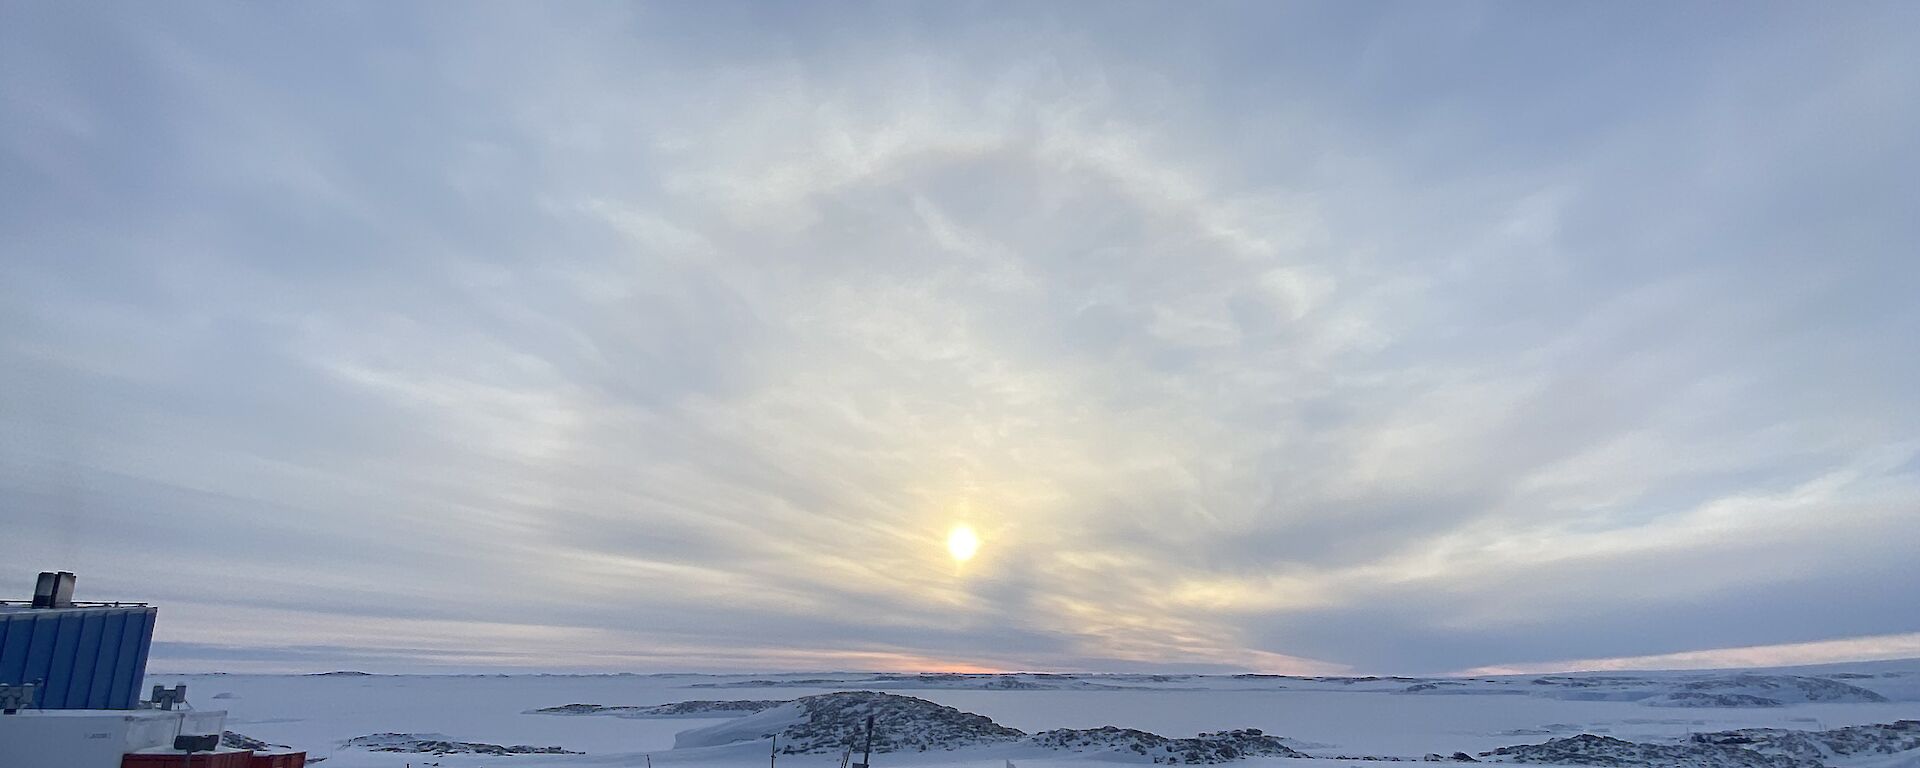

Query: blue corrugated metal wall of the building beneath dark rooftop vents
[[0, 607, 157, 708]]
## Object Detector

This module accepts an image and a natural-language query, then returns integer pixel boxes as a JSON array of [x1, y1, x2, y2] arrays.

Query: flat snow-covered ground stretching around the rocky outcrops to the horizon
[[148, 660, 1920, 768]]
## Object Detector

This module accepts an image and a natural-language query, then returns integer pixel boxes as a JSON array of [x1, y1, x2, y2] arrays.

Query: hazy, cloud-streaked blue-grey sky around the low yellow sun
[[0, 0, 1920, 674]]
